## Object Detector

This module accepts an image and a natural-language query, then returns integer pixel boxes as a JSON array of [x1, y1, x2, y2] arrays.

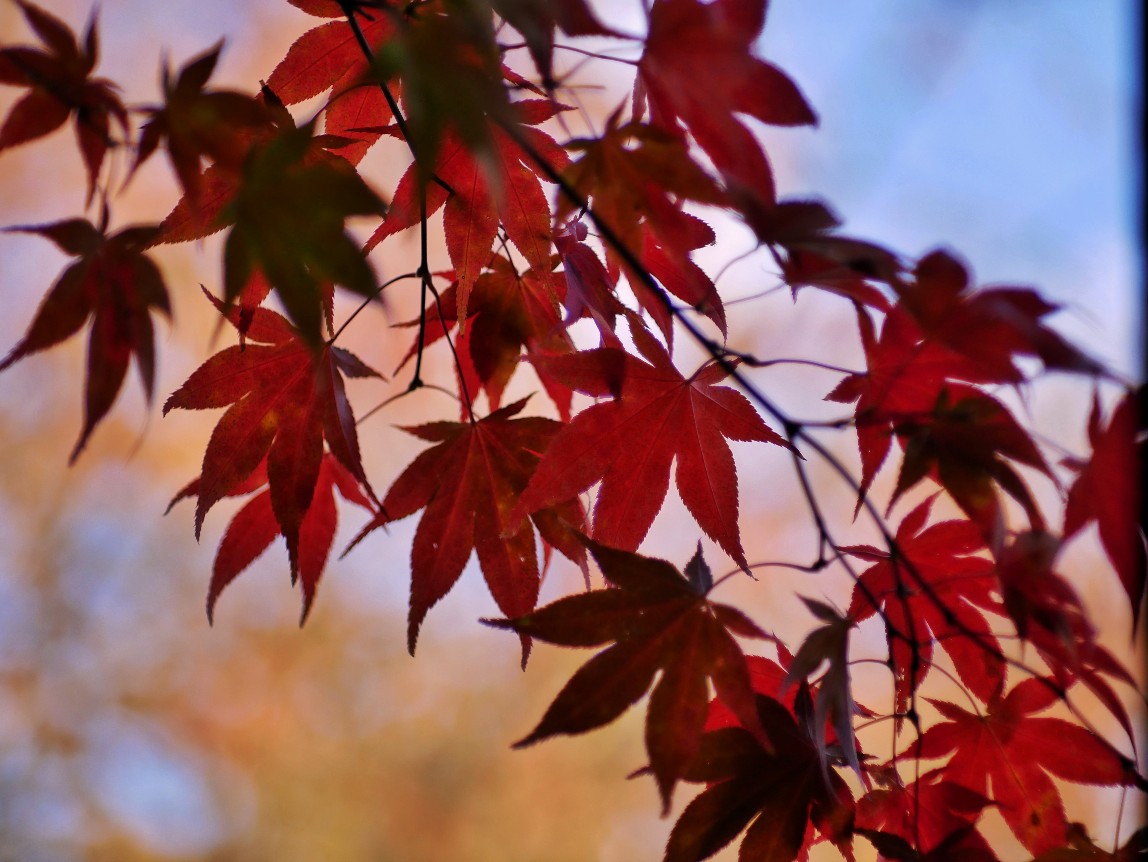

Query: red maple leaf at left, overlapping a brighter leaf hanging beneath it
[[163, 292, 379, 575]]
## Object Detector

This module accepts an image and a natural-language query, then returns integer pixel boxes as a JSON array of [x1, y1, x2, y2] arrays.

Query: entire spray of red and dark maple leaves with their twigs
[[0, 0, 1148, 862]]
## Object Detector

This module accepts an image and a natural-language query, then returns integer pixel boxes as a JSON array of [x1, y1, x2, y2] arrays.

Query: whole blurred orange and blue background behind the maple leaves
[[0, 0, 1142, 862]]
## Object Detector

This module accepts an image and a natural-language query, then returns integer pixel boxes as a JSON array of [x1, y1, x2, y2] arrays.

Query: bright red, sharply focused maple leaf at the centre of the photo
[[515, 326, 786, 568]]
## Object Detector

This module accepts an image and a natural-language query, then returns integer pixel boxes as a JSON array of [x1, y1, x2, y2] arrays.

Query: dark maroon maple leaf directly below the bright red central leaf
[[484, 539, 766, 810]]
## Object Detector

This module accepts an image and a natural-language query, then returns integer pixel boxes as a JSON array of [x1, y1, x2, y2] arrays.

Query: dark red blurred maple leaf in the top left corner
[[0, 0, 129, 201]]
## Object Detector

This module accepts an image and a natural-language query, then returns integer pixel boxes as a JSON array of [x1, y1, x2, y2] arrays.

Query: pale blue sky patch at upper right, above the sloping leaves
[[763, 0, 1141, 372]]
